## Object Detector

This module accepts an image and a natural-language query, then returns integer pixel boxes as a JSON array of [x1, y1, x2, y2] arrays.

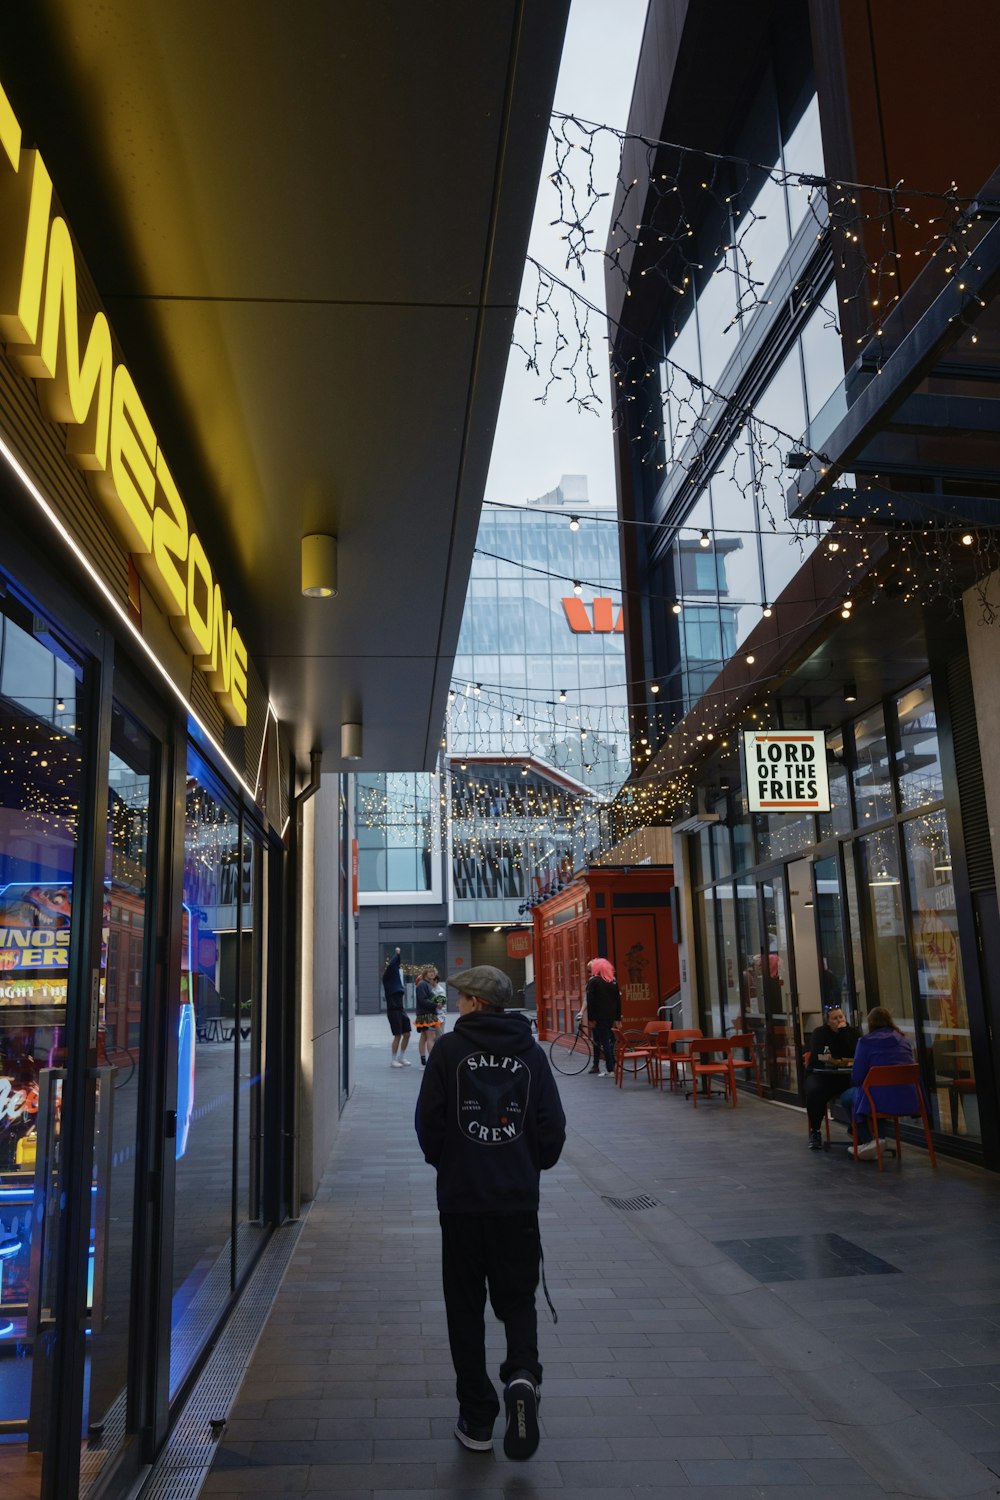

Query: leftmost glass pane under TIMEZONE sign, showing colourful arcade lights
[[0, 591, 83, 1470]]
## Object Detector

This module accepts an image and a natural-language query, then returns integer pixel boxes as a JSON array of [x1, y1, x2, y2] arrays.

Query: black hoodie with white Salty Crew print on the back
[[417, 1011, 565, 1214]]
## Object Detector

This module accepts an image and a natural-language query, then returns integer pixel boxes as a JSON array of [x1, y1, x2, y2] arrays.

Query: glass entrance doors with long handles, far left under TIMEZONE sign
[[0, 564, 172, 1500]]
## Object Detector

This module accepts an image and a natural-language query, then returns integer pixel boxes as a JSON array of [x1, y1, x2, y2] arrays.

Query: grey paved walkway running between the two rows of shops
[[204, 1017, 1000, 1500]]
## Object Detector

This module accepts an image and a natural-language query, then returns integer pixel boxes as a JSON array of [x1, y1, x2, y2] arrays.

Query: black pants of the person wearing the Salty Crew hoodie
[[441, 1211, 541, 1427]]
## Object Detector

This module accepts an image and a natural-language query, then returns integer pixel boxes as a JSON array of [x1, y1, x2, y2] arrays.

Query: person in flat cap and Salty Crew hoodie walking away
[[417, 965, 565, 1458]]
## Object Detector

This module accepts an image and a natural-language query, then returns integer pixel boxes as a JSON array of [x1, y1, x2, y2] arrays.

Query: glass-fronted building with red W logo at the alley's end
[[357, 476, 630, 1002]]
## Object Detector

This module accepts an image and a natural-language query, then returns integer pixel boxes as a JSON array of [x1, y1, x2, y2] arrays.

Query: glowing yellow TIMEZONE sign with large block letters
[[0, 80, 247, 726]]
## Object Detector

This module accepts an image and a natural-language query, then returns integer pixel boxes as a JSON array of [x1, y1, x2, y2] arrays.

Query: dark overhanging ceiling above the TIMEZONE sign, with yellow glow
[[0, 0, 568, 771]]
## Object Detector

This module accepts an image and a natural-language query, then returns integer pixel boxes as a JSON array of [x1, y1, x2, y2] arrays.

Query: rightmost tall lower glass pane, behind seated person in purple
[[903, 812, 981, 1140]]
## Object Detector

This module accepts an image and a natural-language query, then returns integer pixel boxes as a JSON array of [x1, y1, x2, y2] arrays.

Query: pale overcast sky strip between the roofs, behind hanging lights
[[486, 0, 646, 504]]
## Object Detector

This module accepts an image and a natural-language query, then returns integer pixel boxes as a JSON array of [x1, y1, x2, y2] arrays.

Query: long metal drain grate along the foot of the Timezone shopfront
[[139, 1221, 301, 1500]]
